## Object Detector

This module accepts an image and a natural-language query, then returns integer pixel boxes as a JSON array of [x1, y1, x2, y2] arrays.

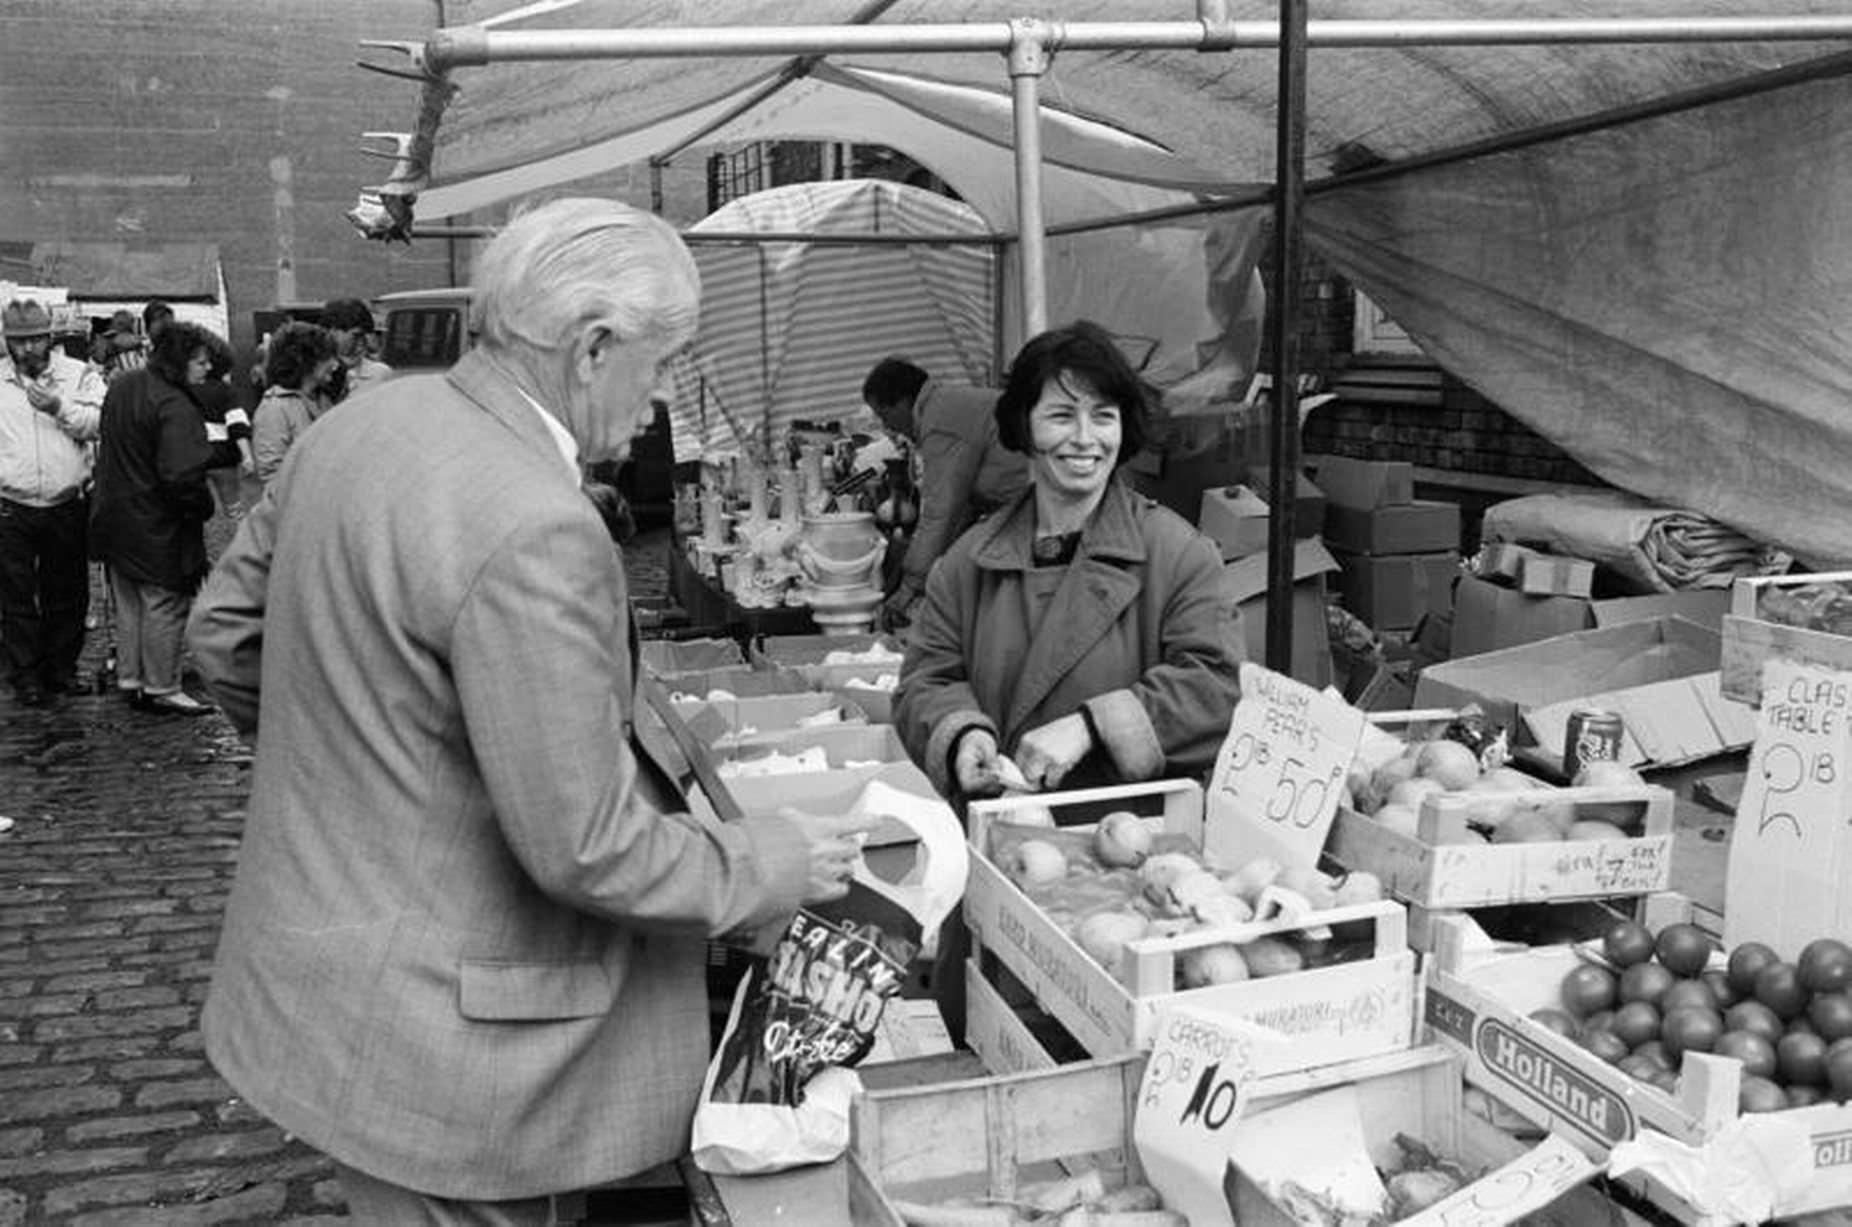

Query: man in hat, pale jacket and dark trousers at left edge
[[0, 298, 104, 707]]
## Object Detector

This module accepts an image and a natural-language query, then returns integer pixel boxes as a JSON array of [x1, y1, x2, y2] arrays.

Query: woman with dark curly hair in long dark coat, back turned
[[91, 324, 213, 716]]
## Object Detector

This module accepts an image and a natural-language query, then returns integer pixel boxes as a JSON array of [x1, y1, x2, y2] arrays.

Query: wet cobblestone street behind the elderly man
[[0, 520, 681, 1227]]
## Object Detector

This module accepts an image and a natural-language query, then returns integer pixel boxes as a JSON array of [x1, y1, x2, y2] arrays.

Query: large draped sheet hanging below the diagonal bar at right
[[1306, 60, 1852, 566]]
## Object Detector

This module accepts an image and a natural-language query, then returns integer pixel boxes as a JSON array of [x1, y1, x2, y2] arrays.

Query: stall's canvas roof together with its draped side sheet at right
[[353, 0, 1852, 563]]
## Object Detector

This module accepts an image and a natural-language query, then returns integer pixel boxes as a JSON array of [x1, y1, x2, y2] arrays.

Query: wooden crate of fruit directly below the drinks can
[[1326, 785, 1674, 911]]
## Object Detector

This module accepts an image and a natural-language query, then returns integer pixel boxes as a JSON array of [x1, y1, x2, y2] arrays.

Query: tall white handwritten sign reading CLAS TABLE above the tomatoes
[[1724, 659, 1852, 959]]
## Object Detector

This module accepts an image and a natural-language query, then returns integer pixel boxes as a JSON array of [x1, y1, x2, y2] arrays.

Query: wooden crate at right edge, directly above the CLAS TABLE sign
[[1722, 572, 1852, 707]]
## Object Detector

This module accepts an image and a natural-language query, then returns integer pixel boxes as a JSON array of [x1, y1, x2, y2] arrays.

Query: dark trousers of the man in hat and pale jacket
[[0, 498, 91, 687]]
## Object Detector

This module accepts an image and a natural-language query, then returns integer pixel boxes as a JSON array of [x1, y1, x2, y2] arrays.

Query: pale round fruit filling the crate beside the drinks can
[[1343, 735, 1646, 844]]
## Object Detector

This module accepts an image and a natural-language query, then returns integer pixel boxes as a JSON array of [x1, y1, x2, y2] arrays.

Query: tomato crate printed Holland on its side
[[1426, 918, 1852, 1227]]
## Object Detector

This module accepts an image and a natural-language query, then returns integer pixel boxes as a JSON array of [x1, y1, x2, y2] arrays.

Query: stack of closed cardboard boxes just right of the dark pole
[[1319, 455, 1459, 631]]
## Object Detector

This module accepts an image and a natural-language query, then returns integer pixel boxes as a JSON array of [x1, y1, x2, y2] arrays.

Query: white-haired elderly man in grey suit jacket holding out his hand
[[191, 200, 865, 1223]]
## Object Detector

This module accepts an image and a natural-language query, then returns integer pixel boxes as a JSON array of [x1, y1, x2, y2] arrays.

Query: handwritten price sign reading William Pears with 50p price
[[1204, 663, 1365, 868]]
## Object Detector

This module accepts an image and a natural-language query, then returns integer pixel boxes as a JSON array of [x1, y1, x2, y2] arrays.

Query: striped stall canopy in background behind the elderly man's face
[[669, 180, 996, 459]]
